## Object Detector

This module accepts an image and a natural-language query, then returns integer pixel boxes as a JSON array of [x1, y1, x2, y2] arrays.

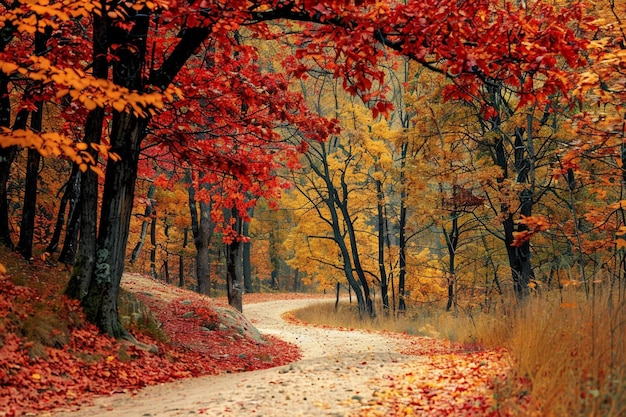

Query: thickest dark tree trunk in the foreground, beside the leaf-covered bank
[[70, 7, 149, 340]]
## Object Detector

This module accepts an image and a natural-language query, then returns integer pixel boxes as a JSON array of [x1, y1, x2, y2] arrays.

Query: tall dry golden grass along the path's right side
[[295, 288, 626, 417]]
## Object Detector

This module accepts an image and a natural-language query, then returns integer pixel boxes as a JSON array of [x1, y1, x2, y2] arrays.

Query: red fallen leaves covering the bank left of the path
[[0, 277, 299, 417]]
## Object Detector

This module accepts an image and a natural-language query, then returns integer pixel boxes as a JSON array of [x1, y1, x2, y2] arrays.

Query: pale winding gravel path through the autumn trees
[[55, 300, 420, 417]]
